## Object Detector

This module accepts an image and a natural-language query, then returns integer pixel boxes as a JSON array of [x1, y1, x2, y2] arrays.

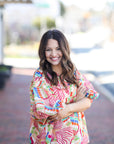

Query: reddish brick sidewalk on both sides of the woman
[[0, 68, 114, 144]]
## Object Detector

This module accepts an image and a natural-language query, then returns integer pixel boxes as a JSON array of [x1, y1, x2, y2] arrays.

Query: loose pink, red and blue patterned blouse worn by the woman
[[29, 68, 99, 144]]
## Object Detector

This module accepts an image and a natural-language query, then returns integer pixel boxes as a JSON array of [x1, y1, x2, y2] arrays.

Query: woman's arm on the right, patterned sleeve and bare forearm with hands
[[49, 70, 99, 121]]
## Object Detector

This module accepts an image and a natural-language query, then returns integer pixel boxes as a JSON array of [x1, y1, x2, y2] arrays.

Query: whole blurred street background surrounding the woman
[[0, 0, 114, 144]]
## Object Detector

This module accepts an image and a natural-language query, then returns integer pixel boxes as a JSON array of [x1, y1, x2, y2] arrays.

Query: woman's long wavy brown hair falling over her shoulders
[[38, 29, 78, 87]]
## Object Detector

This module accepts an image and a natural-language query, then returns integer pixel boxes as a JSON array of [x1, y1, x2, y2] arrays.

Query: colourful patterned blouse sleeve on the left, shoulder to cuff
[[30, 68, 62, 124]]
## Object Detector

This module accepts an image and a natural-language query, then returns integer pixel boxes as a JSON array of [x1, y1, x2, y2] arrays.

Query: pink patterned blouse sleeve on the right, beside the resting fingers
[[76, 70, 99, 100]]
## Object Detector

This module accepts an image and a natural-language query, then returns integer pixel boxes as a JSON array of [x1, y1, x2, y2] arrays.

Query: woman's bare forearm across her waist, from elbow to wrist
[[67, 97, 91, 113]]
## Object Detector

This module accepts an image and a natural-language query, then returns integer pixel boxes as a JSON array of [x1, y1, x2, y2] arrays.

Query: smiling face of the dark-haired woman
[[45, 39, 63, 68]]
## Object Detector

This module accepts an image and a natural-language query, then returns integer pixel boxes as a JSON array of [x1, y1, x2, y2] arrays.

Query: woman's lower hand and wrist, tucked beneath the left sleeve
[[48, 105, 72, 122]]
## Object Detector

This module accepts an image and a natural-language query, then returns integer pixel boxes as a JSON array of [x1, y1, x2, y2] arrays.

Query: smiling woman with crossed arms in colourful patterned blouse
[[30, 30, 98, 144]]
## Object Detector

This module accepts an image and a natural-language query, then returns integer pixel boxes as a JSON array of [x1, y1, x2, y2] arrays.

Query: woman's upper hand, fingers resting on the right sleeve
[[76, 86, 87, 101]]
